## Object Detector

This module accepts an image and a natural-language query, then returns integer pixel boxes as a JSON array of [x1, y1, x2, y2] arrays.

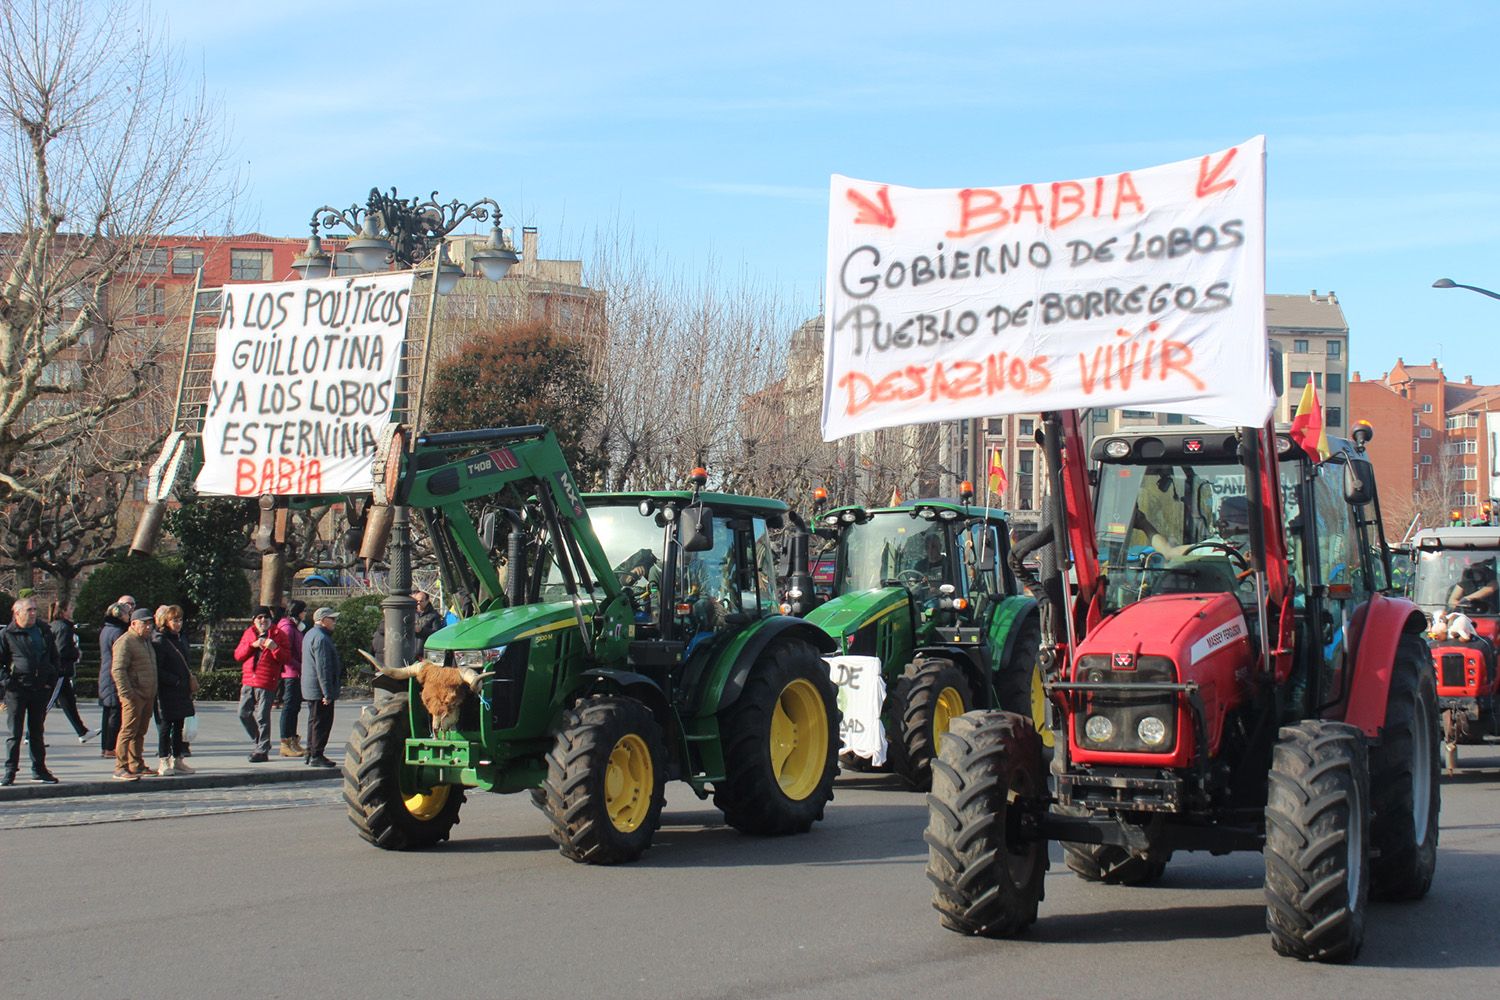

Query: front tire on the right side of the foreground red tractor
[[1265, 720, 1370, 963]]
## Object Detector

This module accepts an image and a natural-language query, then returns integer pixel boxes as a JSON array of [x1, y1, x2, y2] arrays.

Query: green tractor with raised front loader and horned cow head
[[344, 426, 839, 864]]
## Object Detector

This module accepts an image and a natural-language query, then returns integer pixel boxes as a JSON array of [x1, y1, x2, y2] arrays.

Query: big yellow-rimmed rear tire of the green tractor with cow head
[[714, 639, 840, 837]]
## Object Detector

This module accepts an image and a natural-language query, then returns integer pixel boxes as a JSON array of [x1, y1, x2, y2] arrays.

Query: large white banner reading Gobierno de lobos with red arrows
[[824, 136, 1275, 441]]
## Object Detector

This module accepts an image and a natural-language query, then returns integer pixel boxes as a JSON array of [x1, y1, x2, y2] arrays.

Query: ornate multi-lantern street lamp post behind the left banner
[[291, 187, 518, 669]]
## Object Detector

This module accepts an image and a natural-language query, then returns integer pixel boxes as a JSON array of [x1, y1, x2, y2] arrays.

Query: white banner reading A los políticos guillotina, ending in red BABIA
[[197, 271, 413, 496]]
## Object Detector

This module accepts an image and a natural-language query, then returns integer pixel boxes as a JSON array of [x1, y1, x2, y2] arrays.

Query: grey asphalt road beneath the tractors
[[0, 748, 1500, 1000]]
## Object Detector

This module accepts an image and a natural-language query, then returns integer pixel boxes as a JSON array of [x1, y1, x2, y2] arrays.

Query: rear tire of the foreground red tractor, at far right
[[1370, 636, 1442, 900]]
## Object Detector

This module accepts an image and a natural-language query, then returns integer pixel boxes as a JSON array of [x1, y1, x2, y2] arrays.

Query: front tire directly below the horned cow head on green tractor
[[344, 694, 464, 850]]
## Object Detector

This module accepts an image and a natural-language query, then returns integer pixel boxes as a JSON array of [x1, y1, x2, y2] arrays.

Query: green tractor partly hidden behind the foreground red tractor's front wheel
[[788, 490, 1052, 789]]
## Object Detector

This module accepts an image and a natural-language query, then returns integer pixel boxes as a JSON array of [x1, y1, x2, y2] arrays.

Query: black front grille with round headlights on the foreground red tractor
[[1073, 655, 1178, 754]]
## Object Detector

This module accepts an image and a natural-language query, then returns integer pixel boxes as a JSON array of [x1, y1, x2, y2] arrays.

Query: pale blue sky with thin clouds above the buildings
[[155, 0, 1500, 382]]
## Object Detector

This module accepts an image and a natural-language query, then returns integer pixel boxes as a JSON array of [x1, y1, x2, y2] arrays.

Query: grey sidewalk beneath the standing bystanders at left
[[0, 699, 369, 804]]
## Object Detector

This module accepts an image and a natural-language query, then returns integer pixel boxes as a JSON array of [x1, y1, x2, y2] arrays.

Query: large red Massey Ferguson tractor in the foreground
[[926, 412, 1439, 963]]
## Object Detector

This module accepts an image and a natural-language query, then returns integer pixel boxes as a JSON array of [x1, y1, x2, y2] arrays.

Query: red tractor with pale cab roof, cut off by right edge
[[1412, 526, 1500, 774]]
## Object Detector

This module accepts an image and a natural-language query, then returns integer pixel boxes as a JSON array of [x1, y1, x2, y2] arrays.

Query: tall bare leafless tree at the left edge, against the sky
[[0, 0, 234, 593]]
